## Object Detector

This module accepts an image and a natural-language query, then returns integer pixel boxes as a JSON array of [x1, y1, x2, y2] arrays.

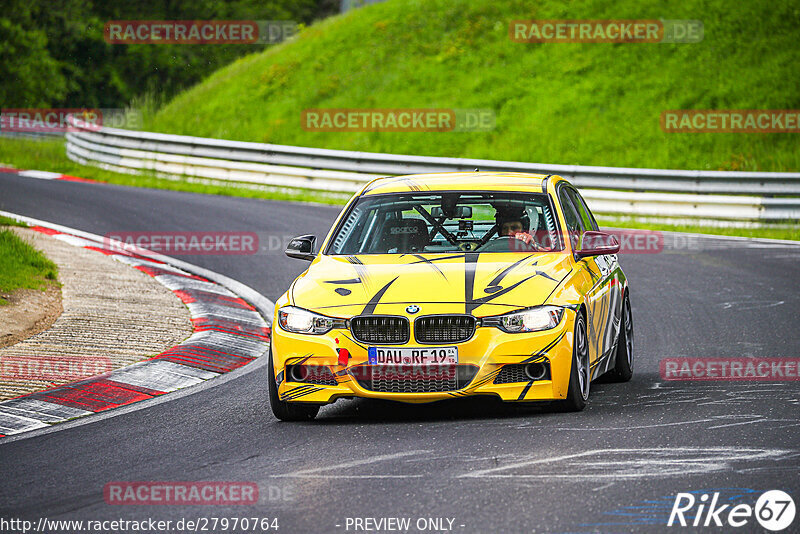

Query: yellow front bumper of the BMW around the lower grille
[[271, 309, 575, 404]]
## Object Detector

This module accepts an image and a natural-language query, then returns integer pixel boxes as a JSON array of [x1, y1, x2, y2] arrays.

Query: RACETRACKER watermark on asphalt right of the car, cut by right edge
[[659, 357, 800, 382]]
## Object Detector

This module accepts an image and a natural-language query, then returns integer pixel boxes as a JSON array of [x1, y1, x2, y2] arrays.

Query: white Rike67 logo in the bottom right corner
[[667, 490, 796, 532]]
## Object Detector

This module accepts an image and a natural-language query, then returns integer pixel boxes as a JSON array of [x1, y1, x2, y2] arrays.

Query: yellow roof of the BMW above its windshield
[[361, 172, 561, 195]]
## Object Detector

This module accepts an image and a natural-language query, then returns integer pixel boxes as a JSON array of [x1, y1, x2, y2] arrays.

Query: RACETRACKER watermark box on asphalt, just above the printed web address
[[103, 481, 258, 506]]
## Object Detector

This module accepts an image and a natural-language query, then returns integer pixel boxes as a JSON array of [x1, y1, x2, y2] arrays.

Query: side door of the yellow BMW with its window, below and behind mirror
[[559, 185, 621, 372]]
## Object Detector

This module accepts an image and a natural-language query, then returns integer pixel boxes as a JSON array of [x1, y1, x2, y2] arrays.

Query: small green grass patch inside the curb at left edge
[[0, 224, 58, 306]]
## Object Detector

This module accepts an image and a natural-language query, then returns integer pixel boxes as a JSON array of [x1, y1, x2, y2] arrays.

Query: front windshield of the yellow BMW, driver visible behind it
[[326, 192, 561, 255]]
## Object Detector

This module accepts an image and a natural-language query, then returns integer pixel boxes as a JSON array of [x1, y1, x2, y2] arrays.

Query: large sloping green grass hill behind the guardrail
[[144, 0, 800, 171]]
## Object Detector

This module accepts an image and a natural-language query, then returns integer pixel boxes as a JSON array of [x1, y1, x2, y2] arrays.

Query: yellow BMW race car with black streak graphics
[[269, 172, 633, 421]]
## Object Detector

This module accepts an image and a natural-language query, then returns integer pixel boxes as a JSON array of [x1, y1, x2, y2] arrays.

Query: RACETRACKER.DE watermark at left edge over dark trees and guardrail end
[[0, 108, 142, 134]]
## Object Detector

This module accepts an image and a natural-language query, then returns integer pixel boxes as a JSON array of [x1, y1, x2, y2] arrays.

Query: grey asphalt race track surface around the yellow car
[[0, 174, 800, 532]]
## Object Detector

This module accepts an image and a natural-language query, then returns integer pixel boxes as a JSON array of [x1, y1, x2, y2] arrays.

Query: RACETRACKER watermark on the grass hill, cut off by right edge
[[659, 109, 800, 133]]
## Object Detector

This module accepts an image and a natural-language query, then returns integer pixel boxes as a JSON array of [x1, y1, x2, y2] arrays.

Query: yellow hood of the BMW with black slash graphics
[[291, 252, 571, 317]]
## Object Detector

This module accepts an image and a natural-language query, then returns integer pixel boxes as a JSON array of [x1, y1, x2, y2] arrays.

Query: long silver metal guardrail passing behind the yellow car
[[66, 118, 800, 222]]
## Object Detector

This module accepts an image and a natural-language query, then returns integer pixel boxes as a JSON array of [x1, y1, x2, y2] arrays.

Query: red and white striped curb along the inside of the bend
[[0, 211, 272, 437]]
